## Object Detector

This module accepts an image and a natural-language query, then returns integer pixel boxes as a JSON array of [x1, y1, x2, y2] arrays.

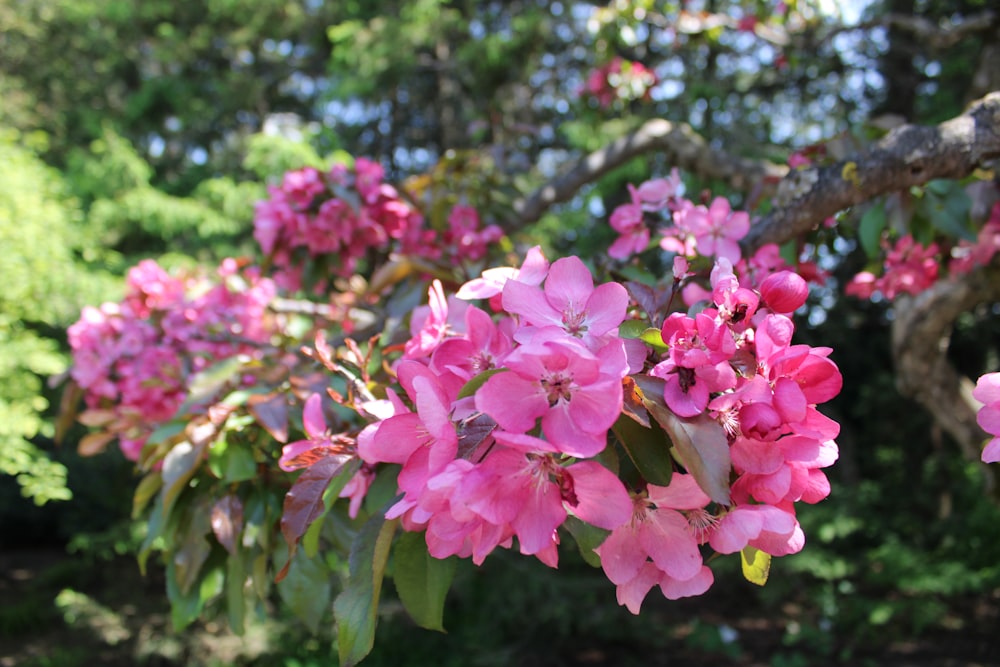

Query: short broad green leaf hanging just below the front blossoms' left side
[[393, 532, 456, 632]]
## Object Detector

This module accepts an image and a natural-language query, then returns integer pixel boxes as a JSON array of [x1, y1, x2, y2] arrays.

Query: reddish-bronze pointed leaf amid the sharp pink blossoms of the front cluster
[[636, 375, 732, 505]]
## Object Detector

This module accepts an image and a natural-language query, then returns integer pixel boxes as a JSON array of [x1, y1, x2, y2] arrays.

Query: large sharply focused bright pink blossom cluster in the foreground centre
[[338, 243, 841, 613]]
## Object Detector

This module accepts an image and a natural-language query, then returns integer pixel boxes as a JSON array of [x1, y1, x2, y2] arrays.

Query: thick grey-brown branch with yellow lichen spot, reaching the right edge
[[743, 92, 1000, 251]]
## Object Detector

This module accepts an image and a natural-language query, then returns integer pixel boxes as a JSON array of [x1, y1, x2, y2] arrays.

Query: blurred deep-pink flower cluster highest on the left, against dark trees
[[254, 158, 502, 291]]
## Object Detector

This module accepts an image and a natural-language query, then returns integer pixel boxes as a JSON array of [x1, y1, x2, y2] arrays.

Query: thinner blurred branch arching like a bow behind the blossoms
[[514, 118, 788, 226]]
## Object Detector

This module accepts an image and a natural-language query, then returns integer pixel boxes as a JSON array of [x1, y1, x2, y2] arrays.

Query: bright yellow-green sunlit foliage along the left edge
[[0, 133, 117, 504]]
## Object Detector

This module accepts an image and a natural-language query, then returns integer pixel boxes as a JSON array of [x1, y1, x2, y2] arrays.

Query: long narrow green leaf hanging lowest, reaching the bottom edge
[[333, 510, 399, 667]]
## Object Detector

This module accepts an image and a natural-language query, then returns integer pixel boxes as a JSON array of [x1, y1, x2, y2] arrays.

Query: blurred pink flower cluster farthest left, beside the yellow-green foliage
[[68, 259, 275, 460]]
